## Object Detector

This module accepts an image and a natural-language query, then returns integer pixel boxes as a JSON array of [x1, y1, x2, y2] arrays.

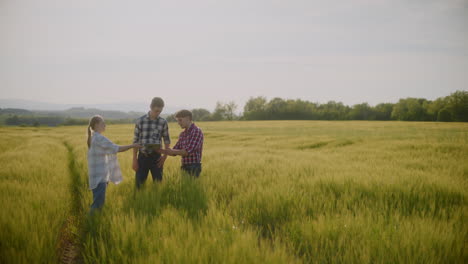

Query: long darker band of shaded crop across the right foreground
[[231, 181, 467, 238]]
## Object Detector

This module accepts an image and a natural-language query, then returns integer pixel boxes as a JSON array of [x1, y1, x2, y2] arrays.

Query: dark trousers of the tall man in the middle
[[135, 153, 163, 188]]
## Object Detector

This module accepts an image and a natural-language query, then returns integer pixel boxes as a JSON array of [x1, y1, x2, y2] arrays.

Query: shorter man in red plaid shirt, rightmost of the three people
[[160, 110, 203, 177]]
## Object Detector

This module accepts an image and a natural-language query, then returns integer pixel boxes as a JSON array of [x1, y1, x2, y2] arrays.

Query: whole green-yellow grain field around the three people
[[0, 121, 468, 263]]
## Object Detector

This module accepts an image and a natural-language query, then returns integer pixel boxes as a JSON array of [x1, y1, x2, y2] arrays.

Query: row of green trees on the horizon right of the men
[[167, 91, 468, 122]]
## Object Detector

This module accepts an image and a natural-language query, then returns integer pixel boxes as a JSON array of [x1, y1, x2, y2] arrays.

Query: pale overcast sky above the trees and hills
[[0, 0, 468, 110]]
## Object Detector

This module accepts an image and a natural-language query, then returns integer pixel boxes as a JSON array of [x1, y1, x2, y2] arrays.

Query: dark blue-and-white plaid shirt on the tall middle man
[[133, 113, 171, 154]]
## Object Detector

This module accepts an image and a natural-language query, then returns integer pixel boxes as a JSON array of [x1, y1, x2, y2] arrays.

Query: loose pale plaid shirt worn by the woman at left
[[88, 132, 122, 190]]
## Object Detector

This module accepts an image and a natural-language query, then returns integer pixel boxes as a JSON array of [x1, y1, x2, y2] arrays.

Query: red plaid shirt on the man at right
[[174, 123, 203, 165]]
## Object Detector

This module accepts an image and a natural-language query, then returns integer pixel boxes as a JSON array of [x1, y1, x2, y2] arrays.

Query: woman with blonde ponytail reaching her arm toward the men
[[87, 115, 140, 213]]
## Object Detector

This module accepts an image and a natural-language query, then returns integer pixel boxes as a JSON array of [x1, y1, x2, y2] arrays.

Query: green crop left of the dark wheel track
[[0, 128, 70, 263]]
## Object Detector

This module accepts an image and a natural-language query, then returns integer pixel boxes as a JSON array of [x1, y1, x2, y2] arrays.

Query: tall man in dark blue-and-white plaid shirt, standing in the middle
[[132, 97, 171, 188]]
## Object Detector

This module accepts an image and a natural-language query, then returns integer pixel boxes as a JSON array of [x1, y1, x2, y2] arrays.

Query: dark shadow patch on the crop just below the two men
[[123, 175, 208, 220]]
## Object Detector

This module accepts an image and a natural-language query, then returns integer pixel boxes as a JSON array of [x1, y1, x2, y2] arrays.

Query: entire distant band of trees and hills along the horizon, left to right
[[0, 91, 468, 126]]
